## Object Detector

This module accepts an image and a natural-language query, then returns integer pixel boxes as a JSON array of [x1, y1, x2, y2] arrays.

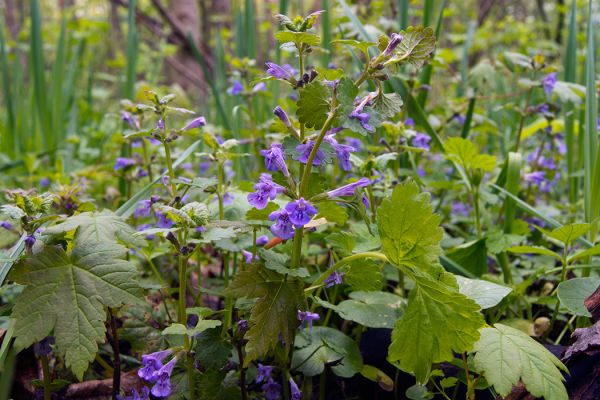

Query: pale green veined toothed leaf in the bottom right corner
[[474, 324, 568, 400]]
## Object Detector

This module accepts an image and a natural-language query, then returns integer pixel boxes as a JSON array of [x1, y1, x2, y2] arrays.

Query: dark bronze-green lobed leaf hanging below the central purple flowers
[[225, 265, 304, 367]]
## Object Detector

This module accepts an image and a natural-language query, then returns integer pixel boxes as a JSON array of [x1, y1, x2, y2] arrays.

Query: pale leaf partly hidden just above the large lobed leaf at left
[[44, 210, 145, 249]]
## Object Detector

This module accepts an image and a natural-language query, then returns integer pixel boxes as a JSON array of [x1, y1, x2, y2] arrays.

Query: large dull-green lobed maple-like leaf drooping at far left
[[10, 242, 142, 380]]
